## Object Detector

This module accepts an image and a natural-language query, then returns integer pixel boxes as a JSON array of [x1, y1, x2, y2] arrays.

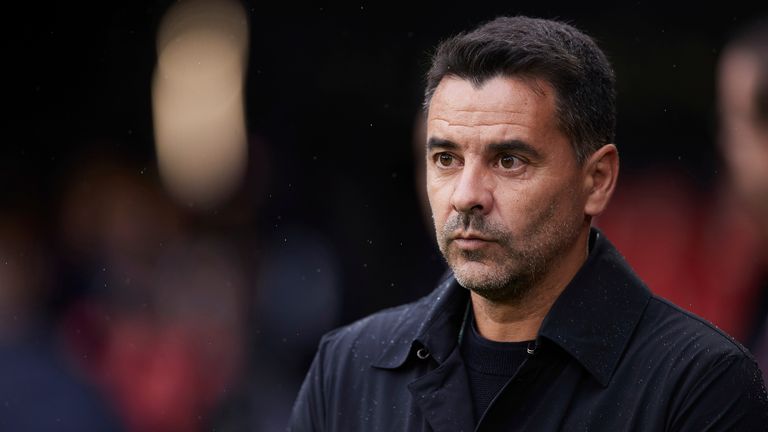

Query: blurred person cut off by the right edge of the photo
[[718, 18, 768, 377]]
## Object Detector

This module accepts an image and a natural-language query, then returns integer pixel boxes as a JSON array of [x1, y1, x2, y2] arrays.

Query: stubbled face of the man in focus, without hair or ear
[[426, 77, 589, 301]]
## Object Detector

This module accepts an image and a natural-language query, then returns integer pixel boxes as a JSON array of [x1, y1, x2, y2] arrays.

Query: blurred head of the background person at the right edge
[[718, 19, 768, 239]]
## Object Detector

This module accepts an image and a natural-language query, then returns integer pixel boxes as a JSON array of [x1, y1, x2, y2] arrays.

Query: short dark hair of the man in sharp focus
[[424, 16, 616, 163]]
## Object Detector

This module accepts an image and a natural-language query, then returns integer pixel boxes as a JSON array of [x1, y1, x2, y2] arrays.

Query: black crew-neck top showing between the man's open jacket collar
[[461, 312, 533, 422]]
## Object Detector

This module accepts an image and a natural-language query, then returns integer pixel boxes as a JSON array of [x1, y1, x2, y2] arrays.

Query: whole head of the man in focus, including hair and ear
[[425, 17, 618, 301]]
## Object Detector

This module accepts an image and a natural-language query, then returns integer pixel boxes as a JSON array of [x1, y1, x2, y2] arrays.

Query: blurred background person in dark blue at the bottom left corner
[[0, 210, 123, 432]]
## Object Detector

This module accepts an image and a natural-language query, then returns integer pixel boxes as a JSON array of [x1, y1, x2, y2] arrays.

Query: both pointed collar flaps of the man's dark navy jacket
[[374, 228, 651, 386]]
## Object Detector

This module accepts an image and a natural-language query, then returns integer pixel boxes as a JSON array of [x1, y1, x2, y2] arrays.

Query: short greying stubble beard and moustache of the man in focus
[[436, 205, 580, 304]]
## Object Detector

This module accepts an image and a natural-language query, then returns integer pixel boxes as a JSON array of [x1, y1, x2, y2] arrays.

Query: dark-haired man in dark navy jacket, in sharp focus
[[290, 17, 768, 431]]
